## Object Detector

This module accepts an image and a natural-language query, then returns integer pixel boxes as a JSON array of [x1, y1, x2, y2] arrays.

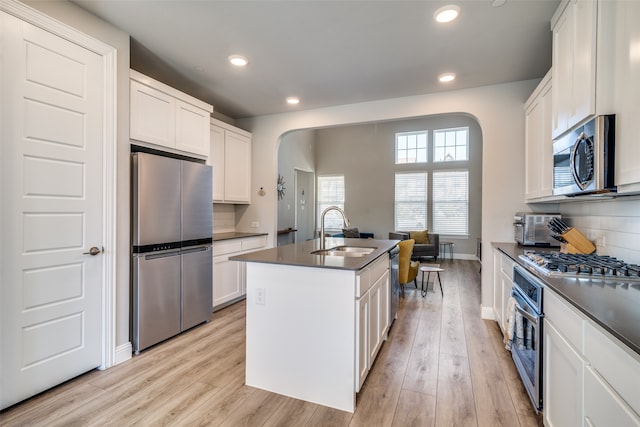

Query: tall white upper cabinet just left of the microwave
[[525, 71, 553, 201]]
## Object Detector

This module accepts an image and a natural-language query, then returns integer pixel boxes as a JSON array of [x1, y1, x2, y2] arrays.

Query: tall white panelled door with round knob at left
[[0, 12, 105, 408]]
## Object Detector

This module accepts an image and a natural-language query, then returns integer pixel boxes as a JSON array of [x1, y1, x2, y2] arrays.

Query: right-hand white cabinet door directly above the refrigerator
[[176, 100, 211, 156]]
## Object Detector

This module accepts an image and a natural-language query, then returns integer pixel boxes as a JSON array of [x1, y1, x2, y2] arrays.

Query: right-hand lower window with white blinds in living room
[[432, 170, 469, 235]]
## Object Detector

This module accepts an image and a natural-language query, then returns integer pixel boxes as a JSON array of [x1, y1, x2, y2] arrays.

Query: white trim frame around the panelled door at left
[[0, 0, 117, 369]]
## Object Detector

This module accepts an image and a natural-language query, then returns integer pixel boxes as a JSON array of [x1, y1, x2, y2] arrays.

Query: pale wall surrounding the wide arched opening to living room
[[237, 80, 539, 307]]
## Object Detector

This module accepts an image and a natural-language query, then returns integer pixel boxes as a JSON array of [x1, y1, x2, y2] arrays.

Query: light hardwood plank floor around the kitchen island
[[0, 260, 541, 427]]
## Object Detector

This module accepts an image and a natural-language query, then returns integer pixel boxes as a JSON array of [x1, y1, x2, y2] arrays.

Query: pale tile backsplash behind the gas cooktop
[[559, 196, 640, 264]]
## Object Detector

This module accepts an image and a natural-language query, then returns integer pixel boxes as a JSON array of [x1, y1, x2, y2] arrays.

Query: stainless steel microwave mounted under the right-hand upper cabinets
[[553, 114, 616, 196]]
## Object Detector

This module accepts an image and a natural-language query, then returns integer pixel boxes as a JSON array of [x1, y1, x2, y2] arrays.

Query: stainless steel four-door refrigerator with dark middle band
[[131, 152, 213, 353]]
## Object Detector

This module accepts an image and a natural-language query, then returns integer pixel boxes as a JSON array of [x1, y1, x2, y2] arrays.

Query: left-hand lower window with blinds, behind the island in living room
[[394, 172, 428, 231]]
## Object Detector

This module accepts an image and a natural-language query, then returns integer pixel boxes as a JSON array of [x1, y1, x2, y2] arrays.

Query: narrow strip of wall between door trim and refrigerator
[[23, 1, 131, 352]]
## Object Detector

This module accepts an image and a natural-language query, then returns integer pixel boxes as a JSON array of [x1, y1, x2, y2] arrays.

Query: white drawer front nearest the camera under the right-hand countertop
[[584, 322, 640, 416]]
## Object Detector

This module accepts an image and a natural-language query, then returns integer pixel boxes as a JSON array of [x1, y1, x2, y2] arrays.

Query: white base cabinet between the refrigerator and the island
[[213, 236, 267, 310]]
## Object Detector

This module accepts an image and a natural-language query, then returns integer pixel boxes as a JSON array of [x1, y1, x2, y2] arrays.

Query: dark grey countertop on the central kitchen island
[[229, 237, 400, 270]]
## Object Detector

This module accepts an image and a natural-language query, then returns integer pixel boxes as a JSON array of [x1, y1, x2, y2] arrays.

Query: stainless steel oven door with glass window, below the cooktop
[[511, 287, 542, 412]]
